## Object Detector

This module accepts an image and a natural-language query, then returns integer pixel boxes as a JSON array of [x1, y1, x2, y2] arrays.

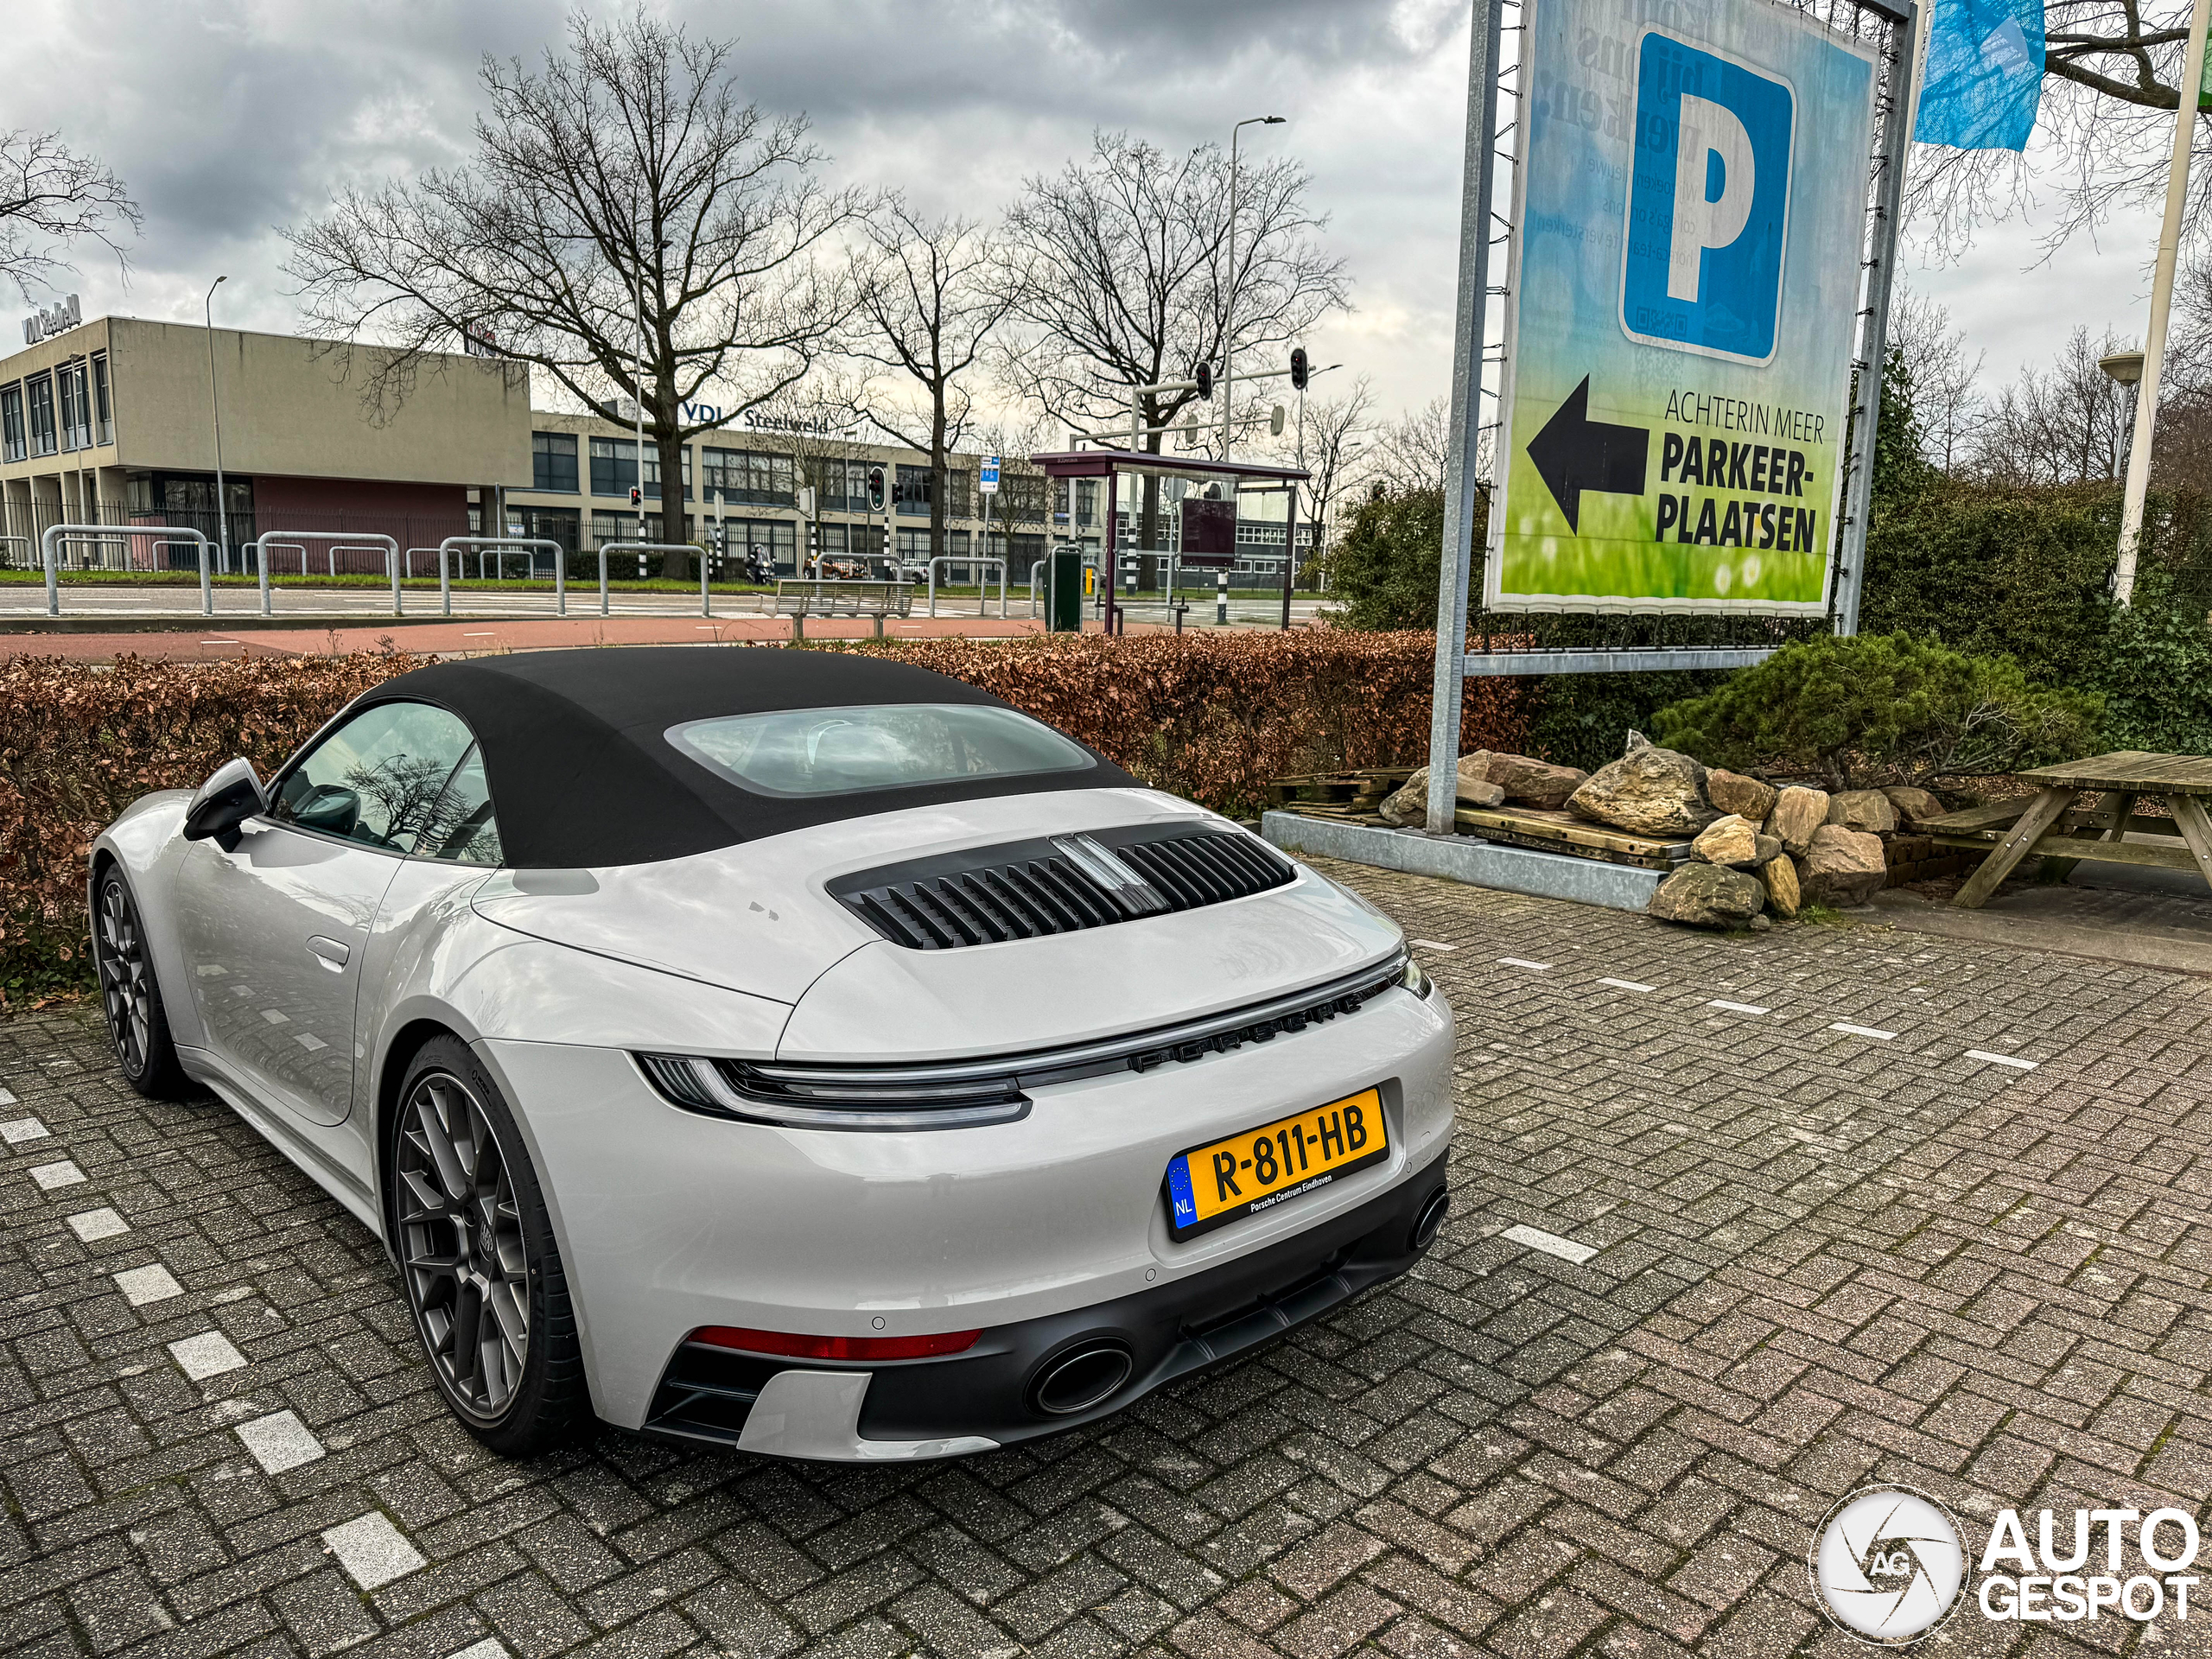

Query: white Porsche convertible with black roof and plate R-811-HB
[[91, 648, 1453, 1460]]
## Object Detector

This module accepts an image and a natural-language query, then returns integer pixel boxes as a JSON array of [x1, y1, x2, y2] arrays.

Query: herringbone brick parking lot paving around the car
[[0, 869, 2212, 1659]]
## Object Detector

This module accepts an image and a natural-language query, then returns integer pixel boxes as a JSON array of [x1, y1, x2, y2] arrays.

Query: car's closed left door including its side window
[[177, 703, 471, 1123]]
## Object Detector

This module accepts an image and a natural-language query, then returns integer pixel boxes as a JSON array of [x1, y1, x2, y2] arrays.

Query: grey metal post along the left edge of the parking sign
[[1429, 0, 1502, 836]]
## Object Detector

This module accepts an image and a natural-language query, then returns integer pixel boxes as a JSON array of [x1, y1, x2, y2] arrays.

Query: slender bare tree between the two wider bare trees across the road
[[852, 197, 1013, 560]]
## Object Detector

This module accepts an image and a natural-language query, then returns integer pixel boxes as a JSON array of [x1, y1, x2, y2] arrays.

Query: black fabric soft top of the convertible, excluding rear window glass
[[354, 646, 1137, 869]]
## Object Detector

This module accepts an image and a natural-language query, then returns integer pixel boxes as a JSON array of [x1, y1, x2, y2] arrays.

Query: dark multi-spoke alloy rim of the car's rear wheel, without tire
[[398, 1071, 531, 1422]]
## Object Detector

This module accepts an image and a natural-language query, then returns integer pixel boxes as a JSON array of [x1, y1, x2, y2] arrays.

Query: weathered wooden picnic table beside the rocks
[[1923, 750, 2212, 909]]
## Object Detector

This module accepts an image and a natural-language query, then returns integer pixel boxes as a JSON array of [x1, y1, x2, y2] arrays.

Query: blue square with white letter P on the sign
[[1621, 29, 1796, 363]]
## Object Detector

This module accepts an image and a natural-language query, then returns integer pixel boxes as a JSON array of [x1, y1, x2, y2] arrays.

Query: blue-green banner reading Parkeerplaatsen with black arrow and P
[[1484, 0, 1876, 613]]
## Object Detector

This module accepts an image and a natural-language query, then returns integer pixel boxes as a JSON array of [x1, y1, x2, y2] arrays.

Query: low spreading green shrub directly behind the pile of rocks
[[1652, 632, 2104, 790]]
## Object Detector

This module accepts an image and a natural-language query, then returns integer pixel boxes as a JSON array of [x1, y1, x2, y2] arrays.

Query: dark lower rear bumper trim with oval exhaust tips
[[644, 1157, 1445, 1462]]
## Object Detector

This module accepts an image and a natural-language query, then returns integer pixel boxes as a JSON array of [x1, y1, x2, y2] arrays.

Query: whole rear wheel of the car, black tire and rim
[[385, 1035, 588, 1458]]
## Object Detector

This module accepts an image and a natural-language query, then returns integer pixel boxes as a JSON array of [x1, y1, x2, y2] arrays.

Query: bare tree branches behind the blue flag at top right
[[1904, 0, 2212, 263]]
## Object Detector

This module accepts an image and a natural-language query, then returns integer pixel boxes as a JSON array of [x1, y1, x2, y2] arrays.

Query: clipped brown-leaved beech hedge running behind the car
[[0, 628, 1529, 998]]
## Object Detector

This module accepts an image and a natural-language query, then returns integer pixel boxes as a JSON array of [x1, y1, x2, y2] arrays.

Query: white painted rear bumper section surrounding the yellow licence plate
[[478, 986, 1453, 1455]]
